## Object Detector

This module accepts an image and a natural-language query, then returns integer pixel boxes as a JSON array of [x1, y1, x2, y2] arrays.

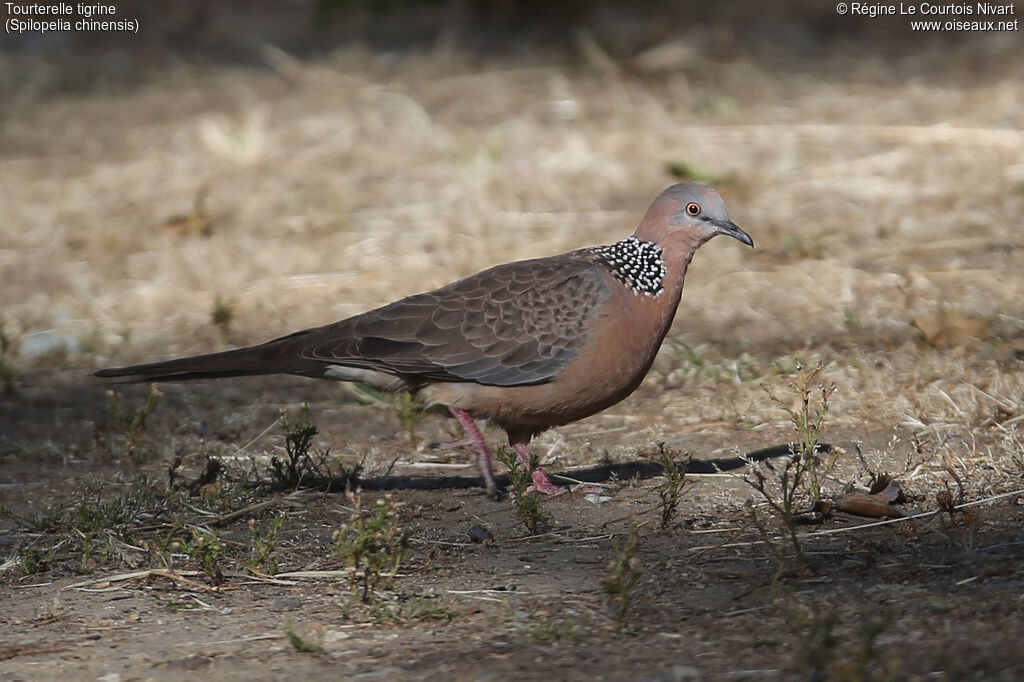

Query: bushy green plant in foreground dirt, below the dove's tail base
[[335, 492, 411, 602]]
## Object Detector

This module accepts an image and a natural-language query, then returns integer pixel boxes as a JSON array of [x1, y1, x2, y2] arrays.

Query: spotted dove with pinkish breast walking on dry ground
[[95, 183, 754, 495]]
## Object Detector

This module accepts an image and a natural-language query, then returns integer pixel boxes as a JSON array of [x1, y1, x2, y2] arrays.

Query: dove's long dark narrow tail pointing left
[[93, 332, 324, 382]]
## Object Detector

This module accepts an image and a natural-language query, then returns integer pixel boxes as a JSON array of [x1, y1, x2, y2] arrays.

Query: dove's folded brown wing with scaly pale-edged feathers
[[299, 252, 609, 386]]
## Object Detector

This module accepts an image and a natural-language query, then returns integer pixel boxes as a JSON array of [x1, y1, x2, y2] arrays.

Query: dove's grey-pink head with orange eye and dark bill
[[636, 182, 754, 249]]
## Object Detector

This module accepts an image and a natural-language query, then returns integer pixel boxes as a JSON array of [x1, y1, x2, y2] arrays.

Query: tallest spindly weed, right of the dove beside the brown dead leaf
[[742, 361, 840, 573]]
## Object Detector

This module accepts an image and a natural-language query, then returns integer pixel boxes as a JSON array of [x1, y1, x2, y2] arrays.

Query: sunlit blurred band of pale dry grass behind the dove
[[0, 45, 1024, 422]]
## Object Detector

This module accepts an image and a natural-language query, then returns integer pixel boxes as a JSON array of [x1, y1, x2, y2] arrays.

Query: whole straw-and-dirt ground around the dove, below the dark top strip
[[0, 2, 1024, 682]]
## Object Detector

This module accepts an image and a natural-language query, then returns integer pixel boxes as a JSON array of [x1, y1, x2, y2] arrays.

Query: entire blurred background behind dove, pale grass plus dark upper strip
[[0, 0, 1024, 430]]
